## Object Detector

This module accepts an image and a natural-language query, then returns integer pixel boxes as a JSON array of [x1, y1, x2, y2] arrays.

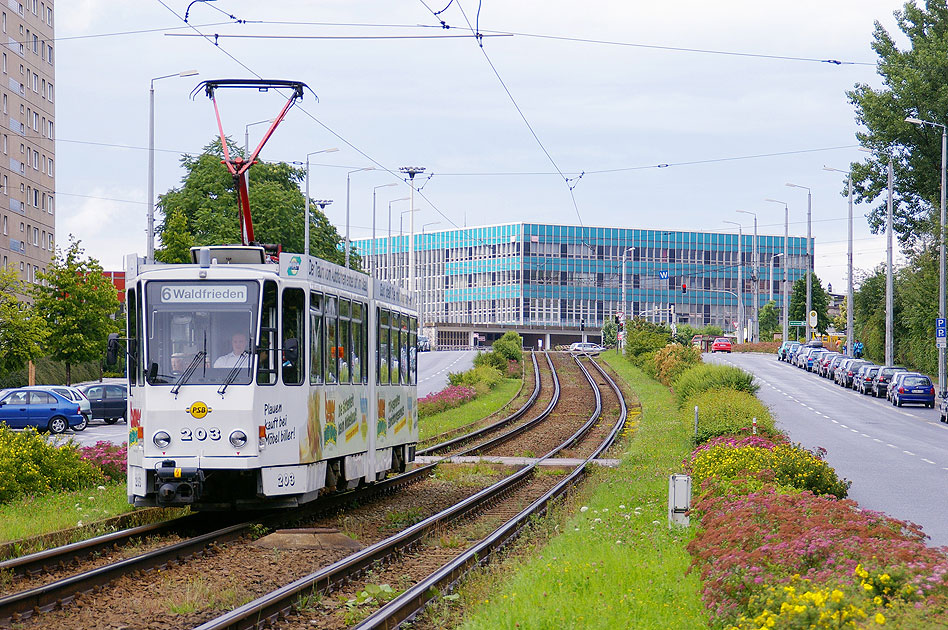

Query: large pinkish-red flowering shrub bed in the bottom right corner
[[688, 485, 948, 628]]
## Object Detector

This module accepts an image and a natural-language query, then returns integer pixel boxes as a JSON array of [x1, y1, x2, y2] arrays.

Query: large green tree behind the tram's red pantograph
[[156, 139, 361, 269]]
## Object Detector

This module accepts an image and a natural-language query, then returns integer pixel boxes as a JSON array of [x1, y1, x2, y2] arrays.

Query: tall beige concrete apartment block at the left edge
[[0, 0, 56, 282]]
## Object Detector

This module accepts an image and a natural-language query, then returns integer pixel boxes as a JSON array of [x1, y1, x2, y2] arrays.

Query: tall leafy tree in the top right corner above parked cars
[[846, 0, 948, 245]]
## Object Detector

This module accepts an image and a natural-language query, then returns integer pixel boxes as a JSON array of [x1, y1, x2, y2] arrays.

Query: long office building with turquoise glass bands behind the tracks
[[353, 223, 806, 345]]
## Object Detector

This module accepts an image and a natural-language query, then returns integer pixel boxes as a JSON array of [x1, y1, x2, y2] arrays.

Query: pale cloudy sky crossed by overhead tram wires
[[56, 0, 902, 293]]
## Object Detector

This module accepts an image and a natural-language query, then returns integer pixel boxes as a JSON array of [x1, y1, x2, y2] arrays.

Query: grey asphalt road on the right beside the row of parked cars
[[699, 353, 948, 546]]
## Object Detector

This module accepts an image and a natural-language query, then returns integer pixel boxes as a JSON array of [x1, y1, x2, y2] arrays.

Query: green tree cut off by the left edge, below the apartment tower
[[0, 267, 49, 374]]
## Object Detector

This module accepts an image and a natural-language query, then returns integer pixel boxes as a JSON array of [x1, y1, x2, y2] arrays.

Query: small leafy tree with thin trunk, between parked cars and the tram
[[33, 235, 119, 385]]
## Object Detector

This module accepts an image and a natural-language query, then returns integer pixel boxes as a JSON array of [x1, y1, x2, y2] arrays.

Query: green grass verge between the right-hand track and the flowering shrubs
[[446, 351, 709, 630]]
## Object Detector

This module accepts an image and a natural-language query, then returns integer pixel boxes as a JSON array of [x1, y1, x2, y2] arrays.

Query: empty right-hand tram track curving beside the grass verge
[[186, 362, 626, 630]]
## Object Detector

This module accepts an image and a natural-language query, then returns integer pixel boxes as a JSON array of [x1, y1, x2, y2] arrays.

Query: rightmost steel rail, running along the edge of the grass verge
[[352, 361, 628, 630]]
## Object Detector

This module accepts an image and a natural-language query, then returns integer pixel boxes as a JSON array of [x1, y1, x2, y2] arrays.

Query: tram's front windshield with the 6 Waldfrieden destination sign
[[145, 281, 259, 386]]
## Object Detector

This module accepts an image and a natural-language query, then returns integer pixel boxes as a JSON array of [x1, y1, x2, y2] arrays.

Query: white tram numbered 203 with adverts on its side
[[116, 246, 418, 510]]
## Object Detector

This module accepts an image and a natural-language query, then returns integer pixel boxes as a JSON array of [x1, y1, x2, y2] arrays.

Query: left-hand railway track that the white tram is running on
[[0, 355, 558, 625]]
